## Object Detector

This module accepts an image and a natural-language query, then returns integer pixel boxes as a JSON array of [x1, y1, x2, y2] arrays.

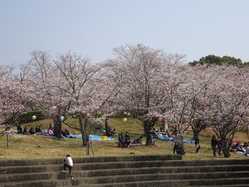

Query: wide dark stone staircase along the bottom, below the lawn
[[0, 155, 249, 187]]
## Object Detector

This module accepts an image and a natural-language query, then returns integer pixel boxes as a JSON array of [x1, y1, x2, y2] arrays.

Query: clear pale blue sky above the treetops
[[0, 0, 249, 66]]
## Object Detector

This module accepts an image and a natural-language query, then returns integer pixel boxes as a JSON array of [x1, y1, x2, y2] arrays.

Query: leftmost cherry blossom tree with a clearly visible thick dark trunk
[[20, 51, 70, 138]]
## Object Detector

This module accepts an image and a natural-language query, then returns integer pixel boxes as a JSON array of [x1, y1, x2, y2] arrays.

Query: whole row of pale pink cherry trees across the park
[[0, 45, 249, 156]]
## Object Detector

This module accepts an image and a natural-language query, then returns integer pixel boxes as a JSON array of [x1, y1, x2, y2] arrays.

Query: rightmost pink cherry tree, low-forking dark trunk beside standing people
[[203, 66, 249, 157]]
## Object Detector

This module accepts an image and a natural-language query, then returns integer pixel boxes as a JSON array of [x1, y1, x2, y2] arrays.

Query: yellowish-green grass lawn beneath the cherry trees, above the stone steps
[[0, 118, 249, 160]]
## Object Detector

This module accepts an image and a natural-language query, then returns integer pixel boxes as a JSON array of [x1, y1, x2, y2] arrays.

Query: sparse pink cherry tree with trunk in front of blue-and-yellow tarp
[[56, 53, 123, 145]]
